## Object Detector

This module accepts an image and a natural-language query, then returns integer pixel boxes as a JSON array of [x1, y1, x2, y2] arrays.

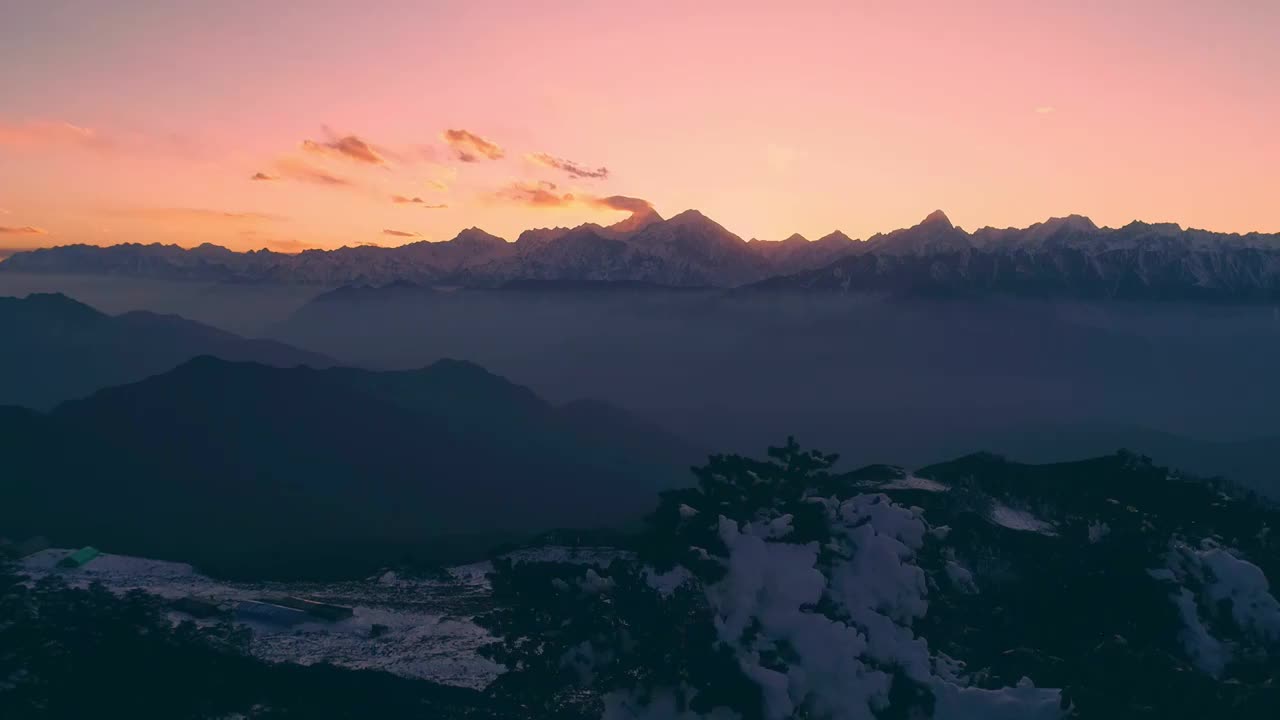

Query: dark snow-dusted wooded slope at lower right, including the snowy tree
[[480, 446, 1280, 720]]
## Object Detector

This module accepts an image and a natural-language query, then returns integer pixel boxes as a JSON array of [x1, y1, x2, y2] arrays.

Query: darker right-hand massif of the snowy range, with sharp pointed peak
[[750, 213, 1280, 302]]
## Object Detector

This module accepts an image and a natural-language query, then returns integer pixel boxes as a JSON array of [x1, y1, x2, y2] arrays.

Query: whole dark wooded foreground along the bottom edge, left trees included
[[0, 440, 1280, 720]]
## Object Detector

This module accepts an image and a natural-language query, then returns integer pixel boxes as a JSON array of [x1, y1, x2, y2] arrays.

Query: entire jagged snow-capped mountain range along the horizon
[[0, 210, 1280, 300]]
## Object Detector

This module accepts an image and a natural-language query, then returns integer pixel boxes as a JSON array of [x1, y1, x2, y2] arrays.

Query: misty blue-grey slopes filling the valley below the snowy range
[[271, 283, 1280, 492]]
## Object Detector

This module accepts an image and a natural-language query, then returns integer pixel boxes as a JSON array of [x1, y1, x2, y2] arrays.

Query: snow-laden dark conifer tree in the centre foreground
[[484, 441, 1065, 720]]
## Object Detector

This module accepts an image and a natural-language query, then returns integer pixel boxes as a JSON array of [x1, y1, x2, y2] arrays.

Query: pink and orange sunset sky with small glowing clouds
[[0, 0, 1280, 251]]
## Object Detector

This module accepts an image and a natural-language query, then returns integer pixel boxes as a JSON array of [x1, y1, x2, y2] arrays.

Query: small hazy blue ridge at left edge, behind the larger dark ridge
[[0, 288, 333, 409]]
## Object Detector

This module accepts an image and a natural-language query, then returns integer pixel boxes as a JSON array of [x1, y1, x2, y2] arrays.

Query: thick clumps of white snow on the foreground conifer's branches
[[691, 493, 1062, 720]]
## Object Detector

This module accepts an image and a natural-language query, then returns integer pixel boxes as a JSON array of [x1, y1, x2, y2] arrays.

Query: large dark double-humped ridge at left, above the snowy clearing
[[0, 356, 699, 573]]
